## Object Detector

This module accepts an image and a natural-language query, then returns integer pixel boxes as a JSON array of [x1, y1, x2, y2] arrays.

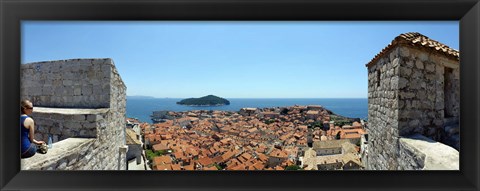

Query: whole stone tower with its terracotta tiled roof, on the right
[[366, 33, 460, 170]]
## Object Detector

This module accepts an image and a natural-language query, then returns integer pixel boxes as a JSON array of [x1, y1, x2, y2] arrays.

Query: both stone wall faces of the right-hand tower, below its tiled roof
[[366, 46, 460, 170]]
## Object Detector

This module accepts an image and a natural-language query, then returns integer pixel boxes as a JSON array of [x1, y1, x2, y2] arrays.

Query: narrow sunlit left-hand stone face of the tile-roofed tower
[[367, 48, 401, 170]]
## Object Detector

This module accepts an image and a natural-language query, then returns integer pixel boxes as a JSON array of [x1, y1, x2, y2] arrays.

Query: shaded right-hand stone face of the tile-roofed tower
[[398, 47, 460, 141]]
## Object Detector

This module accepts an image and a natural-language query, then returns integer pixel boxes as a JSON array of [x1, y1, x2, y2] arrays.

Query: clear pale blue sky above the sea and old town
[[21, 21, 459, 98]]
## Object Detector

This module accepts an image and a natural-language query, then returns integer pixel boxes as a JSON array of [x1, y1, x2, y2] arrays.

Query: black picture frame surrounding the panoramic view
[[0, 0, 480, 190]]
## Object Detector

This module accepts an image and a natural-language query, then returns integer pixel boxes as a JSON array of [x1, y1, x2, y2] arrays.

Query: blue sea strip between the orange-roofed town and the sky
[[127, 97, 368, 123]]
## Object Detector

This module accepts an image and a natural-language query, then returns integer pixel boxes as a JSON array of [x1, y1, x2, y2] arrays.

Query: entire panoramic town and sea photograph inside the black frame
[[18, 21, 460, 171]]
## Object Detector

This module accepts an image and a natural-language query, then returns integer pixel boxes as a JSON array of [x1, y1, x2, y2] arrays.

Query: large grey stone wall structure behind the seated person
[[21, 59, 127, 170]]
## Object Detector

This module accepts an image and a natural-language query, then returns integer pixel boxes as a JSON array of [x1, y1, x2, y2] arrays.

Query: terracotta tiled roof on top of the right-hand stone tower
[[366, 32, 460, 67]]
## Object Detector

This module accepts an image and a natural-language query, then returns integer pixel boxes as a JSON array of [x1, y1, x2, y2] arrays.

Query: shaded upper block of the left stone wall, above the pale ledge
[[20, 59, 115, 108]]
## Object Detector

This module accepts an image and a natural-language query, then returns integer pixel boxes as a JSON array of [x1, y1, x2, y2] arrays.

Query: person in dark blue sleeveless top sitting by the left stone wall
[[20, 100, 45, 158]]
